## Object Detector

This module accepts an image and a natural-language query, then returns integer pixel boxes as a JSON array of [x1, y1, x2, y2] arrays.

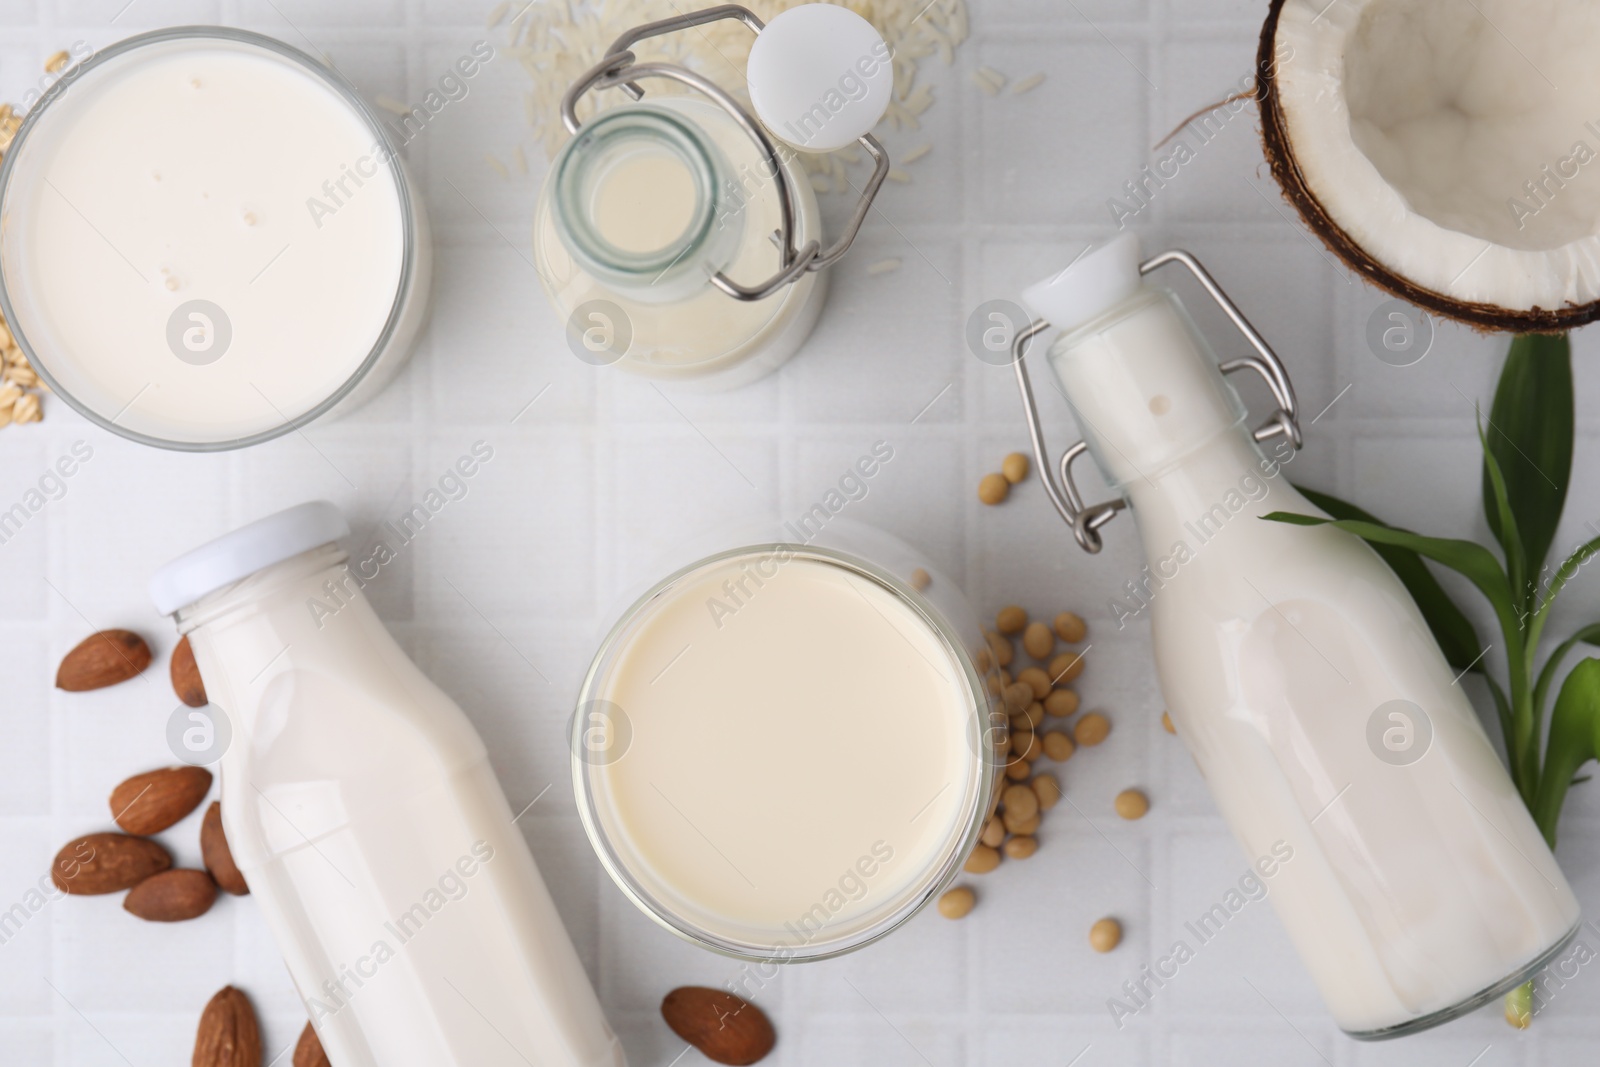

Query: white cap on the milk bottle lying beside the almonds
[[150, 501, 350, 614]]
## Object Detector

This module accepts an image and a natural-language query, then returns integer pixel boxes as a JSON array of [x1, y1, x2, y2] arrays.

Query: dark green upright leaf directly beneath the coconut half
[[1483, 334, 1573, 605]]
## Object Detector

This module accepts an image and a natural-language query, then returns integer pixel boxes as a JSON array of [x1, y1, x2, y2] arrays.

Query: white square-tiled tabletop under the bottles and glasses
[[0, 0, 1600, 1067]]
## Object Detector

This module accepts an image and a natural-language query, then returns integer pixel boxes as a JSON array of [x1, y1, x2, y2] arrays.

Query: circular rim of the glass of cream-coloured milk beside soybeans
[[568, 541, 1000, 963]]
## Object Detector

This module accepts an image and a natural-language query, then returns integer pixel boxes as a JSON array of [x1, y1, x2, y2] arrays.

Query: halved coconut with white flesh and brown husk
[[1256, 0, 1600, 333]]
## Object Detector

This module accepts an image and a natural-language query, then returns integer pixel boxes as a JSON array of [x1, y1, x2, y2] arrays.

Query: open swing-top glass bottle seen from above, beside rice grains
[[534, 3, 894, 389]]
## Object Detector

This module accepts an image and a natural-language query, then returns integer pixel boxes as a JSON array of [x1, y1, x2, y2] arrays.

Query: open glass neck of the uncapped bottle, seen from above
[[550, 104, 744, 304]]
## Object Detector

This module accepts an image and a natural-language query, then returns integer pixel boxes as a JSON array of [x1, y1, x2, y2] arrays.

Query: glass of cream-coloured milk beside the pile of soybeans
[[573, 520, 1005, 961]]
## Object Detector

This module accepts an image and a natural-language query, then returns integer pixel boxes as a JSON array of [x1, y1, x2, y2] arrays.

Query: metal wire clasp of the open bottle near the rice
[[562, 3, 890, 301]]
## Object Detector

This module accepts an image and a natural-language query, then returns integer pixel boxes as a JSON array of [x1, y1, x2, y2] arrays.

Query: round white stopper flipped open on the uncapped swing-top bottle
[[747, 3, 894, 152]]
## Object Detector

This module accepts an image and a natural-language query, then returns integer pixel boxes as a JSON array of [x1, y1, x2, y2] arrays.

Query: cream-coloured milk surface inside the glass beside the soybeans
[[595, 555, 978, 945]]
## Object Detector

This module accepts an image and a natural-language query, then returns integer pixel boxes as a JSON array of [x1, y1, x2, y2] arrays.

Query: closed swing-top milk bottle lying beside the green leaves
[[1016, 235, 1579, 1038]]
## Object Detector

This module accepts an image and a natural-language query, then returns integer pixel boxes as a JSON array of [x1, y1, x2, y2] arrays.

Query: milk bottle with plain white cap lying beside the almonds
[[150, 502, 626, 1067]]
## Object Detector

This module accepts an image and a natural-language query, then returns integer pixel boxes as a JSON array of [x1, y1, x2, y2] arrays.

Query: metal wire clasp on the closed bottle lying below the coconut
[[1011, 250, 1304, 553]]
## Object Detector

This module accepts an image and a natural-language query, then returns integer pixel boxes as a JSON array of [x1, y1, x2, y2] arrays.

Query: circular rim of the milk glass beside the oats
[[0, 26, 418, 453]]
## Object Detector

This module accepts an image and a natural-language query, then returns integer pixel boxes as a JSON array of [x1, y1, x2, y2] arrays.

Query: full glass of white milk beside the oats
[[0, 27, 432, 451]]
